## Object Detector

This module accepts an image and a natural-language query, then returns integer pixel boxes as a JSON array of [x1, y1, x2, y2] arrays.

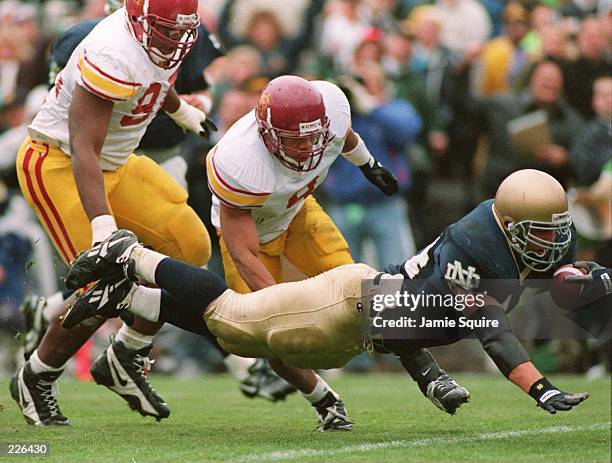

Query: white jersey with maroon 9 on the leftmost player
[[29, 8, 178, 170]]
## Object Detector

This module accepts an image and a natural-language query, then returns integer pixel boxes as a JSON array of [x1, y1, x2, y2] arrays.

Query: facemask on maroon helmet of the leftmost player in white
[[138, 14, 200, 69]]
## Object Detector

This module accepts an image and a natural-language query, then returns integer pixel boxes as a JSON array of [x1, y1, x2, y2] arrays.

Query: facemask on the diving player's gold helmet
[[507, 212, 572, 272]]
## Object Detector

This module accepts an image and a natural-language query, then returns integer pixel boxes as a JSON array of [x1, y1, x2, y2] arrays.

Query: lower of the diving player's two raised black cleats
[[61, 274, 138, 329]]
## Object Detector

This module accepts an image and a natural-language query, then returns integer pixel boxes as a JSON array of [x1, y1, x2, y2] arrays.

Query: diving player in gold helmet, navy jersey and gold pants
[[63, 170, 612, 424]]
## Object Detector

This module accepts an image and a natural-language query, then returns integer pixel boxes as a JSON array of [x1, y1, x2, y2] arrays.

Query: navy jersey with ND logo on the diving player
[[387, 199, 576, 310]]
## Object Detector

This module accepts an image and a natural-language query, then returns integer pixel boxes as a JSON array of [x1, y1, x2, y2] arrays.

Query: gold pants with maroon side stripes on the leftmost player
[[16, 137, 210, 266]]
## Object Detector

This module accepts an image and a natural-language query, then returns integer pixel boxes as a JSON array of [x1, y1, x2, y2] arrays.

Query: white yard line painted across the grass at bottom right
[[231, 423, 610, 463]]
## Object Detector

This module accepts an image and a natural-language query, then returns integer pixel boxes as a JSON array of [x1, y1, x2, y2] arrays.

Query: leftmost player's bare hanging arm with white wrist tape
[[68, 85, 117, 243]]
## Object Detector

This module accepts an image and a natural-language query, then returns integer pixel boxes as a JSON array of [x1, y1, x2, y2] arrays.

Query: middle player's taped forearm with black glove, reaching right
[[342, 128, 399, 196]]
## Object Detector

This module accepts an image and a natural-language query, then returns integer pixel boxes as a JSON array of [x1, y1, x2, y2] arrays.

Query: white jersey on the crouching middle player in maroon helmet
[[206, 81, 351, 243]]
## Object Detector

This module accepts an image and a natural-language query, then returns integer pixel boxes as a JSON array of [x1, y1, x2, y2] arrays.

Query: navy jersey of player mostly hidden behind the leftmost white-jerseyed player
[[50, 18, 225, 151]]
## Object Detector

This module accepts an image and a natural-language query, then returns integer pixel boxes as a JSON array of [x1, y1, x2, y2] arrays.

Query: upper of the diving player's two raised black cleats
[[66, 230, 140, 290]]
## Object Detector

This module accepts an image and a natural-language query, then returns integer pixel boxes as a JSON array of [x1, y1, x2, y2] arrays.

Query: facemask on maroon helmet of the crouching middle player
[[258, 112, 334, 172]]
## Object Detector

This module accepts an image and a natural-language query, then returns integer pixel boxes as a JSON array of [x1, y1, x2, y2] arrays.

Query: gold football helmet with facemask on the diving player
[[493, 169, 572, 272]]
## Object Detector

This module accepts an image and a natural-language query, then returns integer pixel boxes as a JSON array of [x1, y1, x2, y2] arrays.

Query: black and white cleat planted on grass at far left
[[10, 363, 70, 426]]
